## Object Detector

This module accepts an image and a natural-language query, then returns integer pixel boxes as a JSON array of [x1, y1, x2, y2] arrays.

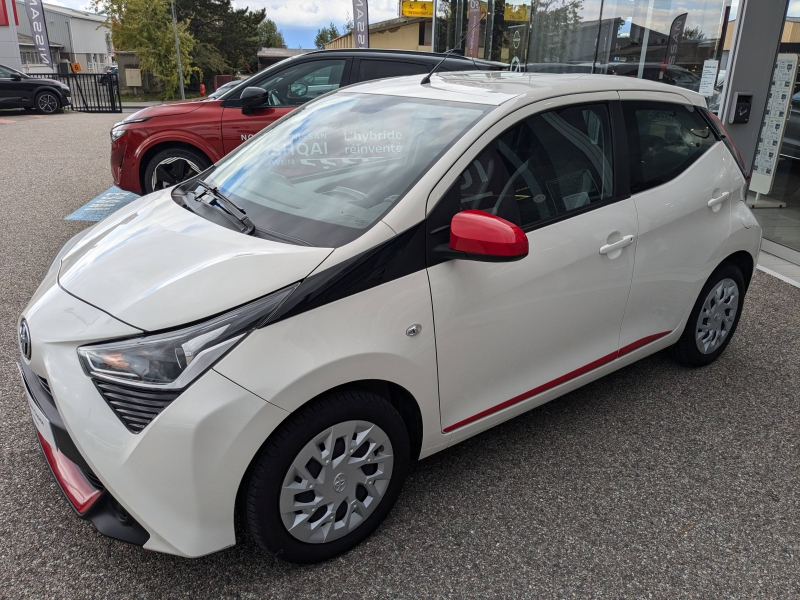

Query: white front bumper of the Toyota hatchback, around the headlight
[[21, 274, 288, 557]]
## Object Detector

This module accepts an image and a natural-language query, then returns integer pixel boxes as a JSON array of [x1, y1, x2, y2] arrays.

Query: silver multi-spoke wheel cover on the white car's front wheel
[[279, 421, 394, 544]]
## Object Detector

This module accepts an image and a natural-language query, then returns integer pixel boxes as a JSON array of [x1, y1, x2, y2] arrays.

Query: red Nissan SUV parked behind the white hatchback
[[111, 49, 508, 194]]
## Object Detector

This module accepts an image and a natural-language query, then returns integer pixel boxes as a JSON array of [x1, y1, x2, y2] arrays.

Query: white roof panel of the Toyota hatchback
[[342, 71, 705, 106]]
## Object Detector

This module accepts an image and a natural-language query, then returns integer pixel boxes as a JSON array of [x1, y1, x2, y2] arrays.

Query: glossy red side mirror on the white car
[[450, 210, 528, 262]]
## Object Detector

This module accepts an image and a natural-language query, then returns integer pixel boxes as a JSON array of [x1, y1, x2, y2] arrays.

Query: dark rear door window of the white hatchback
[[622, 102, 717, 194]]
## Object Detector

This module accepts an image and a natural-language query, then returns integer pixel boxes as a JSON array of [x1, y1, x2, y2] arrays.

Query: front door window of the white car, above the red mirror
[[446, 104, 614, 228]]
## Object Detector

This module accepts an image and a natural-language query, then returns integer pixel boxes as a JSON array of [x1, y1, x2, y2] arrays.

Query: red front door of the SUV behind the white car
[[221, 58, 349, 154]]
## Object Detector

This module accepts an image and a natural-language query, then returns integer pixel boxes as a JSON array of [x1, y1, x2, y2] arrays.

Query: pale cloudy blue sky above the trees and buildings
[[45, 0, 800, 48]]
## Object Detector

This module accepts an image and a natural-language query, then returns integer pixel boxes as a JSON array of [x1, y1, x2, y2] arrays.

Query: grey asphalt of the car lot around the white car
[[0, 113, 800, 599]]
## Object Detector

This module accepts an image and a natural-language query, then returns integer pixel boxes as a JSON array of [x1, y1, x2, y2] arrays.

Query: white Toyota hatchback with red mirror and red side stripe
[[19, 72, 761, 562]]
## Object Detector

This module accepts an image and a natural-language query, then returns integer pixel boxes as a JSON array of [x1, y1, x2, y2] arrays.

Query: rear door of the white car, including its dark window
[[620, 100, 734, 346]]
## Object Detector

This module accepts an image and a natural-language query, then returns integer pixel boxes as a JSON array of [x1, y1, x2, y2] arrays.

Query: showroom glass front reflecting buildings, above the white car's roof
[[434, 0, 726, 96]]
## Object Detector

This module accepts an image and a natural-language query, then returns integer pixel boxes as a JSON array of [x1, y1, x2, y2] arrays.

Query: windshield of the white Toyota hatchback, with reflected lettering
[[200, 93, 490, 248]]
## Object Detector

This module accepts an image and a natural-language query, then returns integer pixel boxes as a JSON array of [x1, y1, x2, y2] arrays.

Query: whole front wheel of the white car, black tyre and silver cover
[[244, 390, 411, 564]]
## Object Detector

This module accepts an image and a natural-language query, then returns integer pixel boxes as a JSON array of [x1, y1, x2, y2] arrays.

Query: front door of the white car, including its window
[[428, 93, 637, 438]]
